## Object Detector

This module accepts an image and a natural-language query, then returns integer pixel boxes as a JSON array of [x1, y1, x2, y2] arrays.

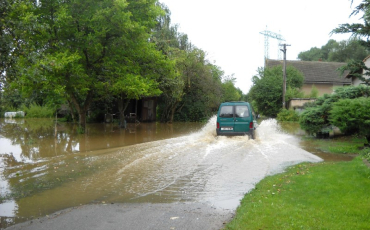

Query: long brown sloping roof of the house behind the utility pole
[[265, 59, 351, 85]]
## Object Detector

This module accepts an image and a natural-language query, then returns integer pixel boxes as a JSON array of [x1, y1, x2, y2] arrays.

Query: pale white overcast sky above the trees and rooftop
[[159, 0, 362, 93]]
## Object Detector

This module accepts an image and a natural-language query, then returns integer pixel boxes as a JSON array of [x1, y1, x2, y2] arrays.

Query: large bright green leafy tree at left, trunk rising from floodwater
[[8, 0, 171, 127]]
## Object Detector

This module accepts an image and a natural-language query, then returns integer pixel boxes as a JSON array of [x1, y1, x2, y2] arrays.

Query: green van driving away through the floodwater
[[216, 101, 257, 139]]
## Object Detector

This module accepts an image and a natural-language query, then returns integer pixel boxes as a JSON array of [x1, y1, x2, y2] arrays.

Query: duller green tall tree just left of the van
[[152, 5, 227, 122]]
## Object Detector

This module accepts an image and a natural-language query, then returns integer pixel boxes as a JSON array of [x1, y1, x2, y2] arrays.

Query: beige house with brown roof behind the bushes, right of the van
[[265, 59, 352, 96]]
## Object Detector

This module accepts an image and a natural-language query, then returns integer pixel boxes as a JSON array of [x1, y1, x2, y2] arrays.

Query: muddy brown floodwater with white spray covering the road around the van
[[0, 117, 346, 228]]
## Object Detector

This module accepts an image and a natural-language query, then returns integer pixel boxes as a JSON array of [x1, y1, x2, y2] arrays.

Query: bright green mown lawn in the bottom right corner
[[225, 157, 370, 229]]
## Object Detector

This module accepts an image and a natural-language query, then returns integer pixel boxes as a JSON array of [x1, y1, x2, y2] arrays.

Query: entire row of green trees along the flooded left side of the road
[[0, 0, 243, 126]]
